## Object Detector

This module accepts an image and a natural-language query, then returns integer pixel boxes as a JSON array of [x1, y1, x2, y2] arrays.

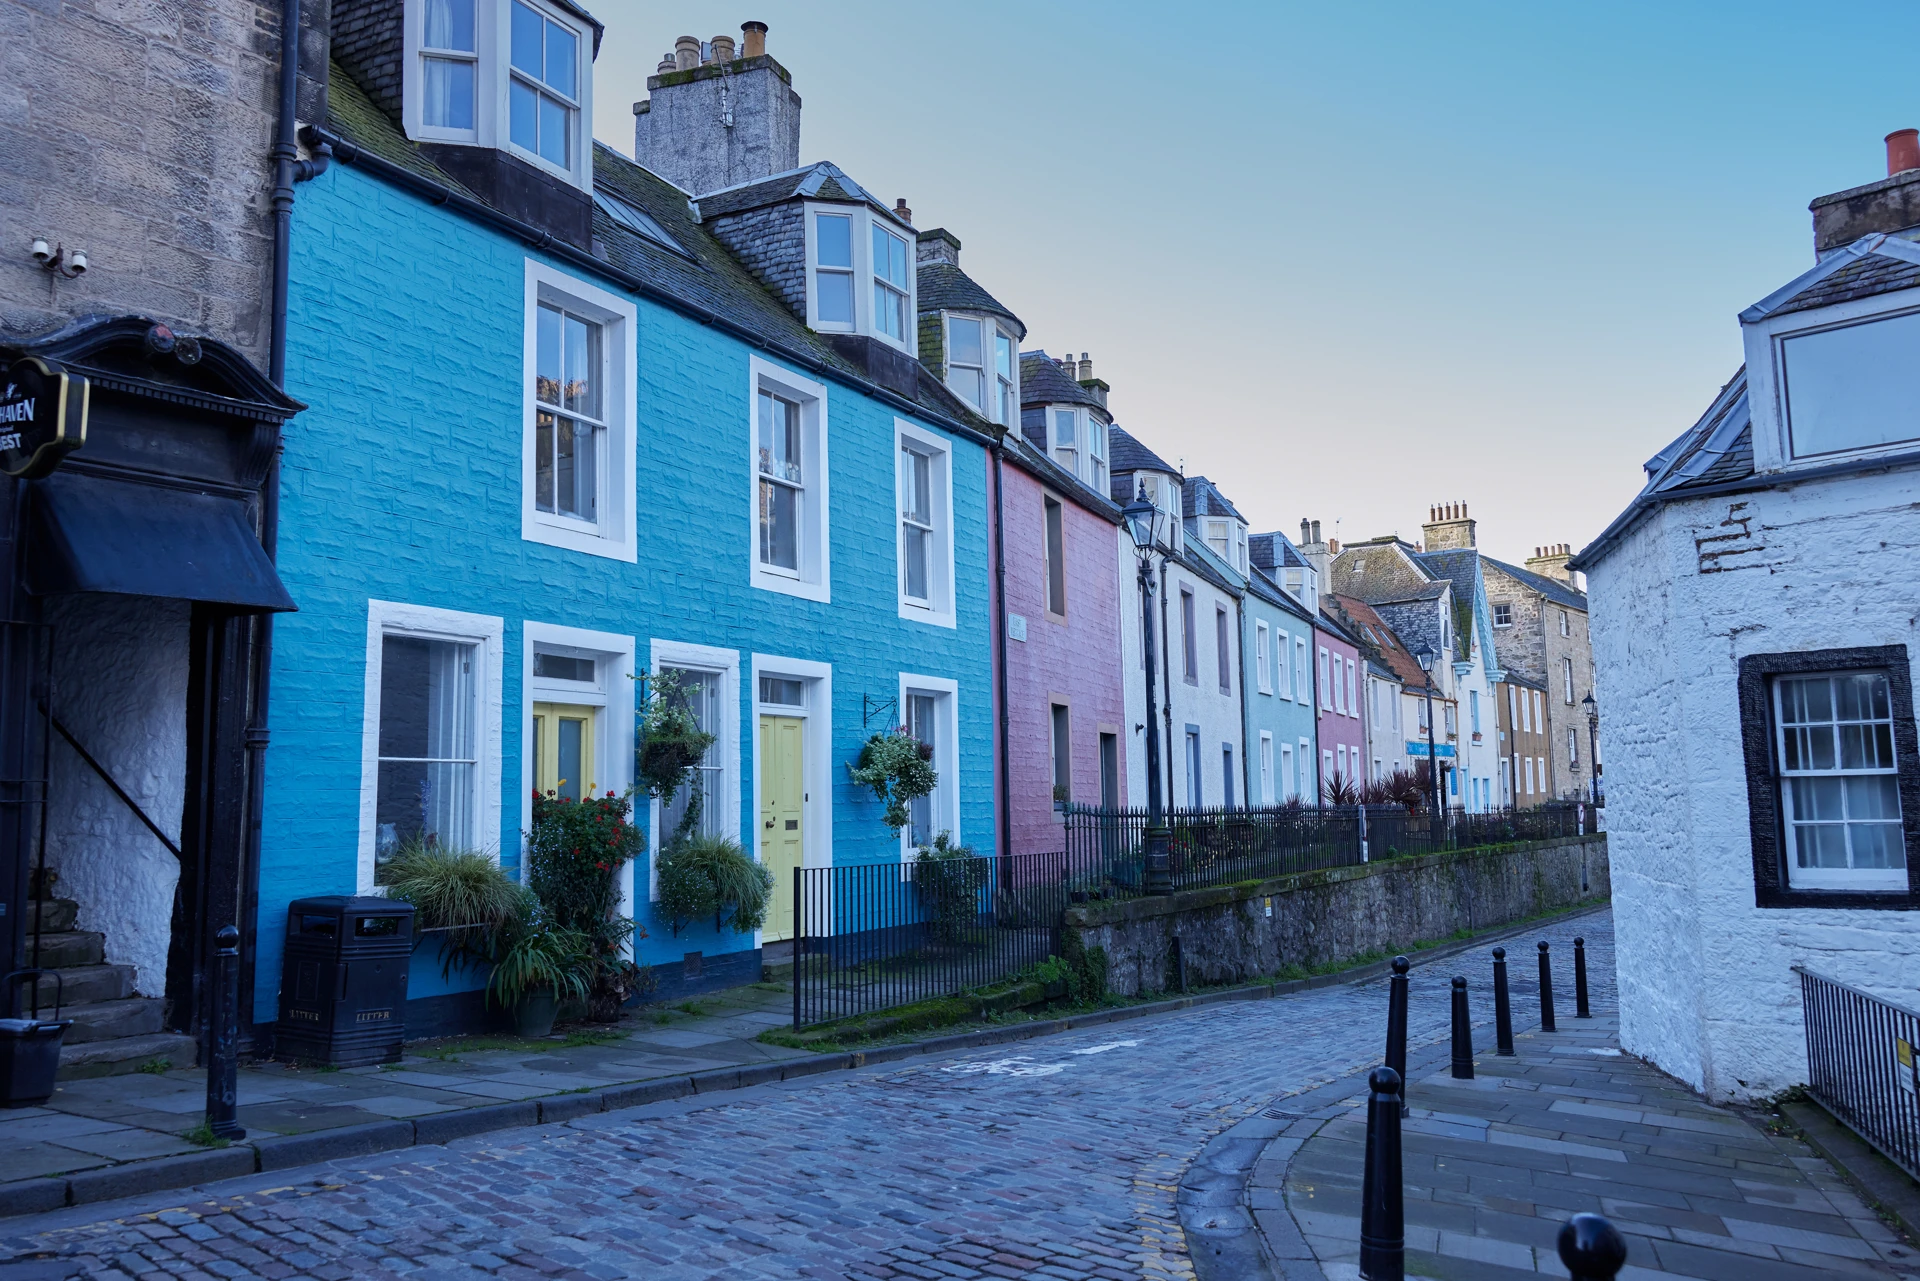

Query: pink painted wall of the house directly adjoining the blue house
[[987, 461, 1127, 855]]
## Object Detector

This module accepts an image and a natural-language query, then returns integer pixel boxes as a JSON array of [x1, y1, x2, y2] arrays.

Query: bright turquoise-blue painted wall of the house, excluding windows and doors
[[255, 165, 995, 1020]]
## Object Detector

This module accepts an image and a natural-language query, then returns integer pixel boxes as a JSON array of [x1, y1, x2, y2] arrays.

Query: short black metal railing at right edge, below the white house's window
[[1793, 966, 1920, 1179]]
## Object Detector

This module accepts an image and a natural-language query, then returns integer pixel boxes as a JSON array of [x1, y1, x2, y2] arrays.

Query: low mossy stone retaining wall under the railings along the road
[[1068, 835, 1613, 997]]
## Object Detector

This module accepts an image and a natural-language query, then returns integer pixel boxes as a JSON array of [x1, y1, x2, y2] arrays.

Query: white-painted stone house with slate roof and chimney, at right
[[1574, 131, 1920, 1099]]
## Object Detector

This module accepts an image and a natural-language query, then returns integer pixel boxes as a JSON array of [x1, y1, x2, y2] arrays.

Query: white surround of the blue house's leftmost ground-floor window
[[355, 599, 499, 893]]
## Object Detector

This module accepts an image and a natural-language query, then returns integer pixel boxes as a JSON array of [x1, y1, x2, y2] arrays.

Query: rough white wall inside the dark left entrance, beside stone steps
[[46, 595, 192, 997]]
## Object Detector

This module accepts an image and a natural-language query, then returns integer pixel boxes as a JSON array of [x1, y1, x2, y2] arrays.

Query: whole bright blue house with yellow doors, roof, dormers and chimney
[[253, 10, 995, 1035]]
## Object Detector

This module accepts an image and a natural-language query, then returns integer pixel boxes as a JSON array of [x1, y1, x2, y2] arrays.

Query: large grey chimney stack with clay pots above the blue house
[[634, 23, 801, 196]]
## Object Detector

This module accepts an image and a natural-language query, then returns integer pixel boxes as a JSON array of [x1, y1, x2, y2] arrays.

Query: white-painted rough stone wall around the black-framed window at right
[[1588, 471, 1920, 1099]]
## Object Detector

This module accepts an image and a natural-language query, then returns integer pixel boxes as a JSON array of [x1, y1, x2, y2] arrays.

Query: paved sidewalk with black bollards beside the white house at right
[[1248, 1001, 1920, 1281]]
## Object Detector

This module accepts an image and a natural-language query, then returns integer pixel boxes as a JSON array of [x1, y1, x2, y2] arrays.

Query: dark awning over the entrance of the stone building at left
[[25, 471, 296, 613]]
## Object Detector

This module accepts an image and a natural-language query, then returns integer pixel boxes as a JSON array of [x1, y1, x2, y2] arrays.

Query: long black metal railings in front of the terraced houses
[[793, 805, 1582, 1027]]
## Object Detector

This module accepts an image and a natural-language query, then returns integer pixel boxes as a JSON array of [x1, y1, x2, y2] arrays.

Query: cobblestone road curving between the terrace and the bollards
[[0, 916, 1613, 1281]]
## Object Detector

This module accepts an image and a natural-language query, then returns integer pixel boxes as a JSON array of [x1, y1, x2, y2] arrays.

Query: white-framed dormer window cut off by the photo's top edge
[[401, 0, 593, 190]]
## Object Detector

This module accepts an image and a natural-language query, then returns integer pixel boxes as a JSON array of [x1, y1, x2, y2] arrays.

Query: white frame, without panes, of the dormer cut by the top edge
[[399, 0, 593, 192]]
